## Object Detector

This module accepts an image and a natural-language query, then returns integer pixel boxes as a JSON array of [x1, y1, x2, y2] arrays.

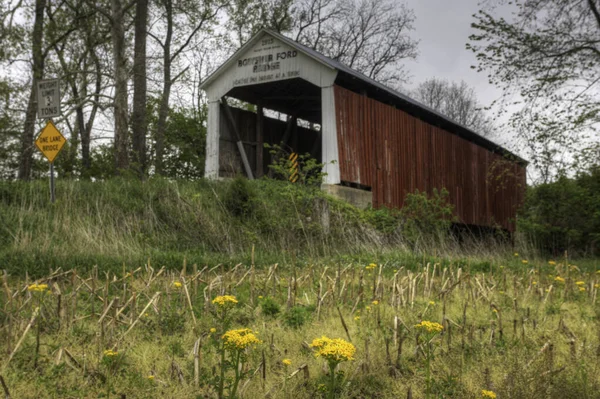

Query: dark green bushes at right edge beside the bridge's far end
[[518, 167, 600, 255]]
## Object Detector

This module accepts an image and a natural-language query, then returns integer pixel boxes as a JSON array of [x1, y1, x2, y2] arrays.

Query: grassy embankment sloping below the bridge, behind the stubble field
[[0, 179, 592, 276]]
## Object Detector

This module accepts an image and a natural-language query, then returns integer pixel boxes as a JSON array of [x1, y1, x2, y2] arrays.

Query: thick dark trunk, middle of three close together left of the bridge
[[131, 0, 148, 178]]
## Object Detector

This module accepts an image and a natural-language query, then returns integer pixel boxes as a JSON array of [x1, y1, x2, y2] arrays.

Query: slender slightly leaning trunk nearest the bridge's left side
[[154, 0, 173, 175]]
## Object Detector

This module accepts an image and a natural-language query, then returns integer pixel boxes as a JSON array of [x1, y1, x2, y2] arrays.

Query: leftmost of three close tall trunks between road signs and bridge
[[111, 0, 129, 174]]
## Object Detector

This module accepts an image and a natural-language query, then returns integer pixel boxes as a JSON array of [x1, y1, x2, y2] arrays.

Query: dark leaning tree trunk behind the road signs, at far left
[[19, 0, 46, 180]]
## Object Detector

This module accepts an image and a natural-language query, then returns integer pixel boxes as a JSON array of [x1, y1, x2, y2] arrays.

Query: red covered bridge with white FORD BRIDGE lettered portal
[[201, 30, 527, 231]]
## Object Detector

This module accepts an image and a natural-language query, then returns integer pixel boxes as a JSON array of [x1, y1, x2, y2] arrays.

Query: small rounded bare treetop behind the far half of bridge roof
[[412, 78, 495, 137]]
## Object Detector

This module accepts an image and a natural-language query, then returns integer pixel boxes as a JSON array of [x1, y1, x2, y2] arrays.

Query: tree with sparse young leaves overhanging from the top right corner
[[467, 0, 600, 180]]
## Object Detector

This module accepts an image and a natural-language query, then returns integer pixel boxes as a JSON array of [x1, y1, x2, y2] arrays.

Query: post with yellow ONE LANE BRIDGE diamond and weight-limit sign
[[35, 79, 67, 203]]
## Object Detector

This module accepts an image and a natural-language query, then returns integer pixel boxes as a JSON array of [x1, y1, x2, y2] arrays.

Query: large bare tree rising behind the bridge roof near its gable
[[292, 0, 418, 86]]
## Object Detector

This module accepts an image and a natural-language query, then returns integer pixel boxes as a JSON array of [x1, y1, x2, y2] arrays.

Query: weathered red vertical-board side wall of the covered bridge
[[335, 86, 526, 231]]
